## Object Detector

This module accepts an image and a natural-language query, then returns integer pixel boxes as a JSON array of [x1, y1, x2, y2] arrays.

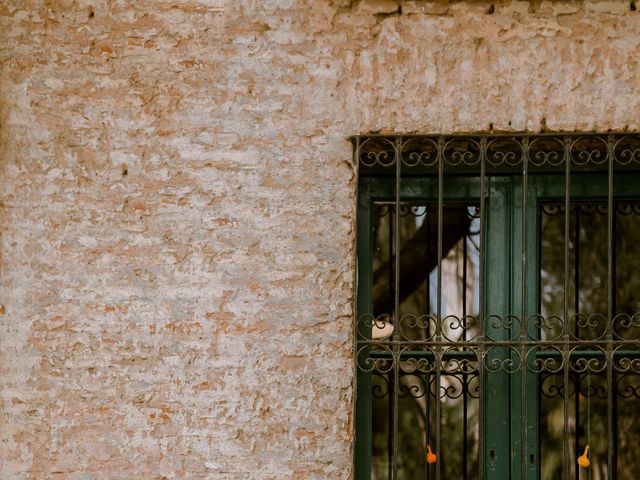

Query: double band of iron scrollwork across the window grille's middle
[[357, 314, 640, 375]]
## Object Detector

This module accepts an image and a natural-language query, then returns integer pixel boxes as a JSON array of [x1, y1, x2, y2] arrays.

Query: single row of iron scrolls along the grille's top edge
[[352, 133, 640, 174]]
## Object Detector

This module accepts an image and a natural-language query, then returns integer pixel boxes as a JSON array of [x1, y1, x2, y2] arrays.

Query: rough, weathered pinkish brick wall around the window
[[0, 0, 640, 480]]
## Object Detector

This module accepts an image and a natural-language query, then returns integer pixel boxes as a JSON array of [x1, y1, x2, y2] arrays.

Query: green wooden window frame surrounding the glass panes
[[353, 134, 640, 480]]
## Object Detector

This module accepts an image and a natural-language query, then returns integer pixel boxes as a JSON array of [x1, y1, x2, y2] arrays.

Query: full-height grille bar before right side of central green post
[[519, 137, 529, 480]]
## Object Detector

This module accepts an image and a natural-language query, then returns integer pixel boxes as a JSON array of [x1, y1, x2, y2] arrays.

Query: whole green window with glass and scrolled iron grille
[[353, 134, 640, 480]]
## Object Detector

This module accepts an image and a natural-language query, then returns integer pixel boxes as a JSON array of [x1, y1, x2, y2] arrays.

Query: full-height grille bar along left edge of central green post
[[477, 137, 487, 480]]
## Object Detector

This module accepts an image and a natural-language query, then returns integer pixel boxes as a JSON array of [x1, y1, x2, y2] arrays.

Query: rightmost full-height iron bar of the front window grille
[[606, 135, 614, 480]]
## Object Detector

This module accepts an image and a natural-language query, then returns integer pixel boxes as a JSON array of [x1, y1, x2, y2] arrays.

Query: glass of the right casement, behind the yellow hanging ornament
[[539, 203, 640, 480]]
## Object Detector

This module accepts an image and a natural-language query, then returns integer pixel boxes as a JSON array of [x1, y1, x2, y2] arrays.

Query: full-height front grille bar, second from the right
[[562, 137, 578, 480]]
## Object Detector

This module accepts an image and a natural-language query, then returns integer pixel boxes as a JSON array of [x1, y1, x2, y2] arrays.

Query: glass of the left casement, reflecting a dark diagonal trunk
[[372, 203, 479, 480]]
